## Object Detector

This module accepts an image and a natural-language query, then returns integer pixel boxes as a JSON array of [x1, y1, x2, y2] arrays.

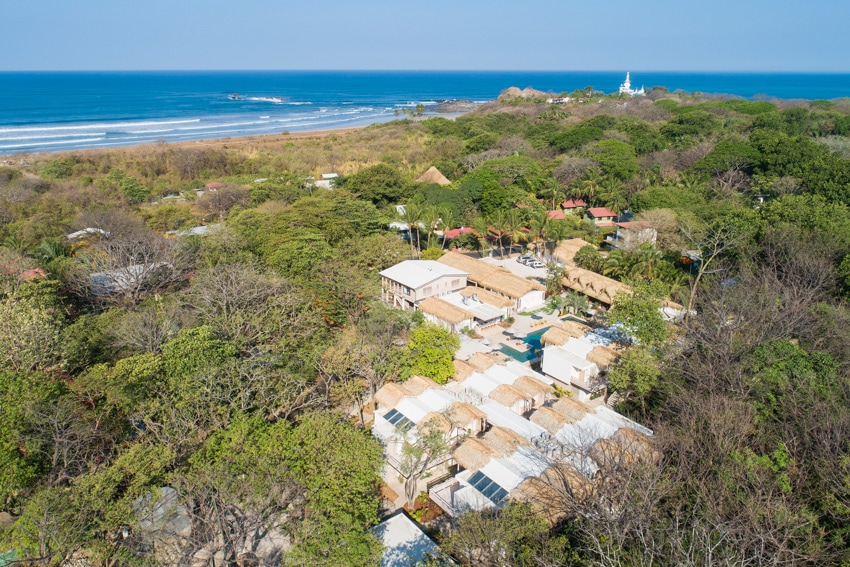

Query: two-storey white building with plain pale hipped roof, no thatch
[[381, 260, 469, 311]]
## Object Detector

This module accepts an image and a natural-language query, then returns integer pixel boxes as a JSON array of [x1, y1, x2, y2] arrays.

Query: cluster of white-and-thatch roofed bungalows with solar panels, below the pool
[[372, 362, 652, 517]]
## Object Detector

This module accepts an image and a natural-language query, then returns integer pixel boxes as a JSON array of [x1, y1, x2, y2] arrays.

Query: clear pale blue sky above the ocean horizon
[[6, 0, 850, 72]]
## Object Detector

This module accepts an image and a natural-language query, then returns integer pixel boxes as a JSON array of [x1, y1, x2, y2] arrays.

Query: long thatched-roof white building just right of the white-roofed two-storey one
[[438, 252, 546, 316]]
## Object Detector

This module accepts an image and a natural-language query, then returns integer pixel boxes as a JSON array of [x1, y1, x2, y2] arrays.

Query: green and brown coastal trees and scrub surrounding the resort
[[0, 88, 850, 566]]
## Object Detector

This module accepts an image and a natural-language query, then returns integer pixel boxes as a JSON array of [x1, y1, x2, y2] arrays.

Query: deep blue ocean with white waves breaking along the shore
[[0, 71, 850, 155]]
